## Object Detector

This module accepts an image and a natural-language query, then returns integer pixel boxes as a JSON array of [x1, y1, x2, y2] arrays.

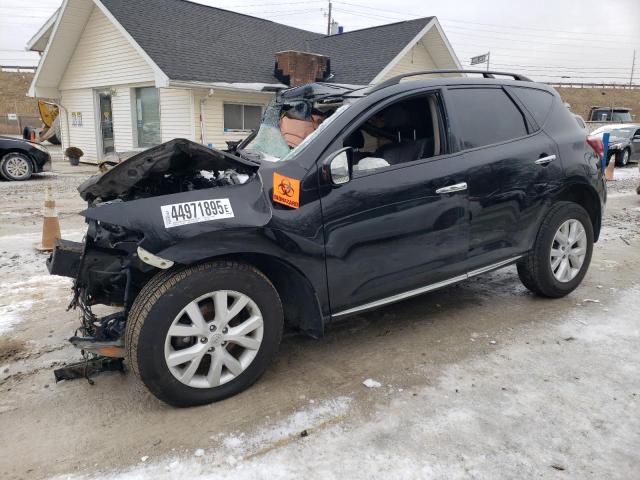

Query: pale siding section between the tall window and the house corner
[[160, 88, 196, 142]]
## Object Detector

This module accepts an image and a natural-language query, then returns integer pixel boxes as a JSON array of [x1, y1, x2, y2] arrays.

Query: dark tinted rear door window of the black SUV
[[448, 88, 529, 149]]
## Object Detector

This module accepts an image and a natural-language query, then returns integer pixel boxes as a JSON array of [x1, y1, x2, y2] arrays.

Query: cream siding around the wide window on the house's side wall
[[194, 90, 274, 149]]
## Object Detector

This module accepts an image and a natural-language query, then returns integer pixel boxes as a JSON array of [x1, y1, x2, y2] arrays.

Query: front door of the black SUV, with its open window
[[321, 94, 468, 316]]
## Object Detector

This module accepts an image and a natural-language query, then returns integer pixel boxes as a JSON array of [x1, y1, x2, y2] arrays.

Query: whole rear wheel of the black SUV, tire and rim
[[517, 202, 594, 298]]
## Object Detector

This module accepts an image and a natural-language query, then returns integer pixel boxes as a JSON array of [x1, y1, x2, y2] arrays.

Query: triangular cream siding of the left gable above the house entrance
[[58, 7, 154, 91]]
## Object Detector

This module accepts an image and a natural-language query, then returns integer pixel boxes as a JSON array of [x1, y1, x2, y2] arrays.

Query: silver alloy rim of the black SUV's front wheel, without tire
[[164, 290, 264, 388]]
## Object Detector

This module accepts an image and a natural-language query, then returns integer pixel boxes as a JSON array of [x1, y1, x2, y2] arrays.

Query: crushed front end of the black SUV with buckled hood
[[47, 139, 261, 380]]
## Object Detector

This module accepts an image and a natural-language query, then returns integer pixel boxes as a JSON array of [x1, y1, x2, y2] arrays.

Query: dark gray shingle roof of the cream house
[[97, 0, 433, 85]]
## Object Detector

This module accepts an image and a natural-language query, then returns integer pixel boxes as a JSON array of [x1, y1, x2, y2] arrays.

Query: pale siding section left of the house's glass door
[[60, 88, 98, 162]]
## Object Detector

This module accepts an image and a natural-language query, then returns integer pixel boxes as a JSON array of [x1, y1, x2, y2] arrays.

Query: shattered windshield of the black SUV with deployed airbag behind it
[[241, 101, 349, 162]]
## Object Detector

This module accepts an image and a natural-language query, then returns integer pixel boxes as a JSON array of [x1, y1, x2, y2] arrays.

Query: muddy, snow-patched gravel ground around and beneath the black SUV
[[0, 163, 640, 479]]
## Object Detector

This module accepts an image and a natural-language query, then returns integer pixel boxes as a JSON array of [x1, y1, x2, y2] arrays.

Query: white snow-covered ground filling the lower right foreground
[[59, 284, 640, 480]]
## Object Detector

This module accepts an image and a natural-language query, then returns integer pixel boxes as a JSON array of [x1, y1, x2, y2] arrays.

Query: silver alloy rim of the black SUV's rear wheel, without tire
[[549, 219, 587, 283]]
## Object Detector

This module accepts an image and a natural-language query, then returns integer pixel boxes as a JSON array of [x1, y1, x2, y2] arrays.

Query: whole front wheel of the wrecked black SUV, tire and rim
[[125, 261, 283, 407]]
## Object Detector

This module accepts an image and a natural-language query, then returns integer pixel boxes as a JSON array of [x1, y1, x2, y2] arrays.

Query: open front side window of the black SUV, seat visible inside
[[343, 93, 445, 177]]
